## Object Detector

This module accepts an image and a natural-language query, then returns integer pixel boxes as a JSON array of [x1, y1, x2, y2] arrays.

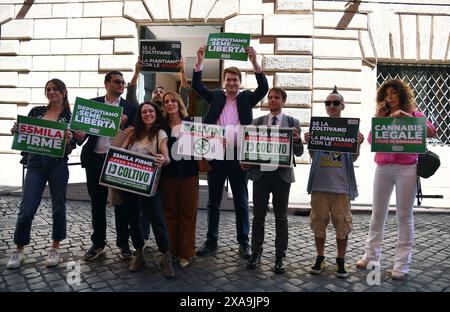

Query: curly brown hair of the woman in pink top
[[375, 79, 416, 117]]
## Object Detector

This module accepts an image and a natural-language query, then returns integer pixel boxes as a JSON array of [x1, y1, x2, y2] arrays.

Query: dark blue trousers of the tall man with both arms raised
[[206, 160, 250, 246]]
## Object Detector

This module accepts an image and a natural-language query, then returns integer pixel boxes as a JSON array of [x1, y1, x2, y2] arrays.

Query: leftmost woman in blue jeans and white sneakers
[[6, 79, 76, 269]]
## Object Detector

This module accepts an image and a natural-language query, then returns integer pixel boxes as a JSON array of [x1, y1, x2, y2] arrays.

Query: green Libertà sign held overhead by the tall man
[[205, 33, 250, 61]]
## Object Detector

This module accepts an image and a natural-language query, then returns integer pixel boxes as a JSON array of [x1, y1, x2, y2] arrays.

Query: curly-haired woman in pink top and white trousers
[[356, 79, 436, 280]]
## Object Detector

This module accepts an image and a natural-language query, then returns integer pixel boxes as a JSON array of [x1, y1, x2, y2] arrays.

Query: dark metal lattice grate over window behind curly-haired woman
[[377, 64, 450, 144]]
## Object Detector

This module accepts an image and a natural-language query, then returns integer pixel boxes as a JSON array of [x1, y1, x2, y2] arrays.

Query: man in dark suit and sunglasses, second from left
[[75, 71, 137, 260]]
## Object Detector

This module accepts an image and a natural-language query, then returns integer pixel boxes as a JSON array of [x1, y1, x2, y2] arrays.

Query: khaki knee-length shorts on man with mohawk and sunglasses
[[310, 192, 353, 239]]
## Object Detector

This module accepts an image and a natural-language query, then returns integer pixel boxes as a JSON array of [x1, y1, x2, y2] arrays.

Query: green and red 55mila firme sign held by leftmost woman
[[11, 115, 67, 157]]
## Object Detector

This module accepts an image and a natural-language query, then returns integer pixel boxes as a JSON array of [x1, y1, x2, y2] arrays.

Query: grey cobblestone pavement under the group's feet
[[0, 197, 450, 292]]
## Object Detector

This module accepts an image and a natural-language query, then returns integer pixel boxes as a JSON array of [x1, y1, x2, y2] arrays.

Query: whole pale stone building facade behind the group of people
[[0, 0, 450, 205]]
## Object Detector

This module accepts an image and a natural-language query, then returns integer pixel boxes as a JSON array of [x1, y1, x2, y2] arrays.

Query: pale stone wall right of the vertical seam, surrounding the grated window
[[310, 0, 450, 207]]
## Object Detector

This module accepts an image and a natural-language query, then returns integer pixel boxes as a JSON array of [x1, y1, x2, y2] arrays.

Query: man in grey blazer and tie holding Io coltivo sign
[[243, 87, 303, 273]]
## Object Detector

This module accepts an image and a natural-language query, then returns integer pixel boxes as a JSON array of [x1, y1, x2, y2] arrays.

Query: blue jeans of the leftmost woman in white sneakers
[[14, 154, 69, 246]]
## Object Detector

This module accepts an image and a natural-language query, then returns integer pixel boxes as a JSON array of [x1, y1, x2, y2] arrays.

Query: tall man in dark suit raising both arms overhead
[[192, 47, 269, 259]]
